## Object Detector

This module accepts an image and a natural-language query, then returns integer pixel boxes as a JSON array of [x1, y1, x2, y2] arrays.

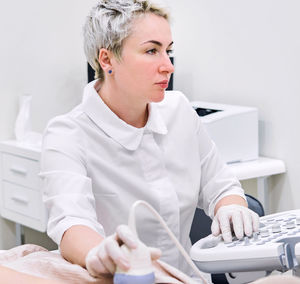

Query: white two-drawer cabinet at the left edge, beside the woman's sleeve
[[0, 141, 47, 232]]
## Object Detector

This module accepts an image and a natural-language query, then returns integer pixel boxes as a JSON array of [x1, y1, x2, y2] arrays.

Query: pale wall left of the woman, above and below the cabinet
[[0, 0, 96, 249]]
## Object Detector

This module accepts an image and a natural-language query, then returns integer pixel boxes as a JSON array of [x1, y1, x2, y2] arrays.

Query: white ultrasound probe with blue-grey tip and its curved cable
[[114, 200, 207, 284]]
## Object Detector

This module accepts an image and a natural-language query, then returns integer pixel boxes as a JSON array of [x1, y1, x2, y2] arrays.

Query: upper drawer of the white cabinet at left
[[2, 153, 40, 189]]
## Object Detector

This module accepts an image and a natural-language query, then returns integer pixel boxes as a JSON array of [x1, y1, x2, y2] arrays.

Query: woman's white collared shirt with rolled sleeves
[[41, 81, 244, 273]]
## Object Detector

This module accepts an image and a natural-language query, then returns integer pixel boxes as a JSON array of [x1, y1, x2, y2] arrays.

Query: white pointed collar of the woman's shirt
[[82, 80, 168, 151]]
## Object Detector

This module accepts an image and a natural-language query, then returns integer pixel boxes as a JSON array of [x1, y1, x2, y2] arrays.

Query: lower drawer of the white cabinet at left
[[2, 182, 44, 220]]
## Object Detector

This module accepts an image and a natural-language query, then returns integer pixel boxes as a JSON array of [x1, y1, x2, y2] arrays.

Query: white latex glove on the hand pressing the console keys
[[211, 204, 259, 243]]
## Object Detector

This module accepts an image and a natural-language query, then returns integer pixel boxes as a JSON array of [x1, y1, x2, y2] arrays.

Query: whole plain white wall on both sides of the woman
[[0, 0, 300, 246]]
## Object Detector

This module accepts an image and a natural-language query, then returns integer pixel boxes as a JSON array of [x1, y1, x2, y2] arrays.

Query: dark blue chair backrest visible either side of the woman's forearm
[[190, 194, 265, 244]]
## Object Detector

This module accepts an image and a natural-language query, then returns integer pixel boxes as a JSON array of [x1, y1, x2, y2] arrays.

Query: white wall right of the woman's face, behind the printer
[[168, 0, 300, 211]]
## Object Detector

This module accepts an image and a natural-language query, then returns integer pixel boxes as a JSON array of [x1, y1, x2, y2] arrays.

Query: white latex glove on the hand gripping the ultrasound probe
[[85, 225, 161, 277]]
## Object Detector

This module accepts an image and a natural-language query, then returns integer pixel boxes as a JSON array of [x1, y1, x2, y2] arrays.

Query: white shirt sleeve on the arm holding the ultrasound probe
[[40, 116, 104, 244]]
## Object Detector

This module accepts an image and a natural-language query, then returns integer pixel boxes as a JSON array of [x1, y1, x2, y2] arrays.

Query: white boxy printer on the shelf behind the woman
[[191, 101, 258, 163]]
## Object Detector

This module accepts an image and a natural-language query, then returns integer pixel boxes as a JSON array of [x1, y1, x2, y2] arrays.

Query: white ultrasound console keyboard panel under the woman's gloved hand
[[190, 209, 300, 283]]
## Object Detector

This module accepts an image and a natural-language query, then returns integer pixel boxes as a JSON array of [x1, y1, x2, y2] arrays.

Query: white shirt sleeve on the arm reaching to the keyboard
[[197, 114, 246, 218]]
